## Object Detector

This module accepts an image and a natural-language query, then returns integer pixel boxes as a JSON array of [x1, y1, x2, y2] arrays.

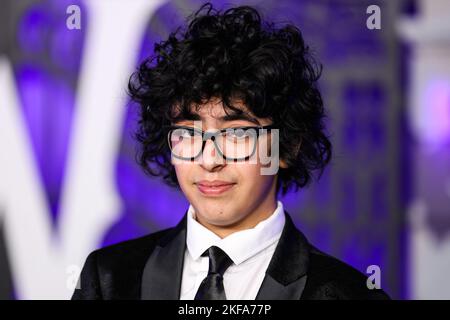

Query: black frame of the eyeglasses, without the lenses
[[164, 125, 277, 162]]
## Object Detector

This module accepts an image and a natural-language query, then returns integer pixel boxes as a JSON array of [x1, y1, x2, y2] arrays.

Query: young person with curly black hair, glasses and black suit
[[73, 4, 388, 299]]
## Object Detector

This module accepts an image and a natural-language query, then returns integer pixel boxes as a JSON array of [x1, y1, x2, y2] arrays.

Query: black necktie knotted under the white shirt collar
[[194, 246, 233, 300]]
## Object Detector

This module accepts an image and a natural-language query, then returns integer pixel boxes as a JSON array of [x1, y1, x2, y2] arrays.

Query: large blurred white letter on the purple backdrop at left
[[0, 0, 166, 299]]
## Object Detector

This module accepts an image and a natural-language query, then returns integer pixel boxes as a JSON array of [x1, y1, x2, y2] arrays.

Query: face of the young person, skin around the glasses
[[172, 99, 284, 237]]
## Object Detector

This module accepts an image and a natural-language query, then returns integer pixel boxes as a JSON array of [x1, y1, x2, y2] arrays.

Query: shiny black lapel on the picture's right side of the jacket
[[256, 211, 309, 300]]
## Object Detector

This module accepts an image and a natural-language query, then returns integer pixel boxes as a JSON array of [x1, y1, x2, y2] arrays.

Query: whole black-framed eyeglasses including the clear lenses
[[166, 125, 275, 161]]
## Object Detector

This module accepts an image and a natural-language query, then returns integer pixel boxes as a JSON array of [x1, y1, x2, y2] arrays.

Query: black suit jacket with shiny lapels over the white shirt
[[72, 211, 389, 300]]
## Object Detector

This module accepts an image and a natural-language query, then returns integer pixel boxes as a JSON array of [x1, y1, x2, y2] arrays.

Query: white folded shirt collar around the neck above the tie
[[186, 201, 286, 265]]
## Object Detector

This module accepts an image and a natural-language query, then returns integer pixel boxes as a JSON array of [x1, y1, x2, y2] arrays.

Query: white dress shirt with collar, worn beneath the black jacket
[[180, 201, 286, 300]]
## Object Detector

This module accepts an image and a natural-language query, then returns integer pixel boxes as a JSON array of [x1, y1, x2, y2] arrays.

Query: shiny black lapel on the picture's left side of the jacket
[[141, 213, 187, 300]]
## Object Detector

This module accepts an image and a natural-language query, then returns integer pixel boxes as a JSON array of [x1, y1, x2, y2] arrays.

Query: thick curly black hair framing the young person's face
[[128, 3, 332, 195]]
